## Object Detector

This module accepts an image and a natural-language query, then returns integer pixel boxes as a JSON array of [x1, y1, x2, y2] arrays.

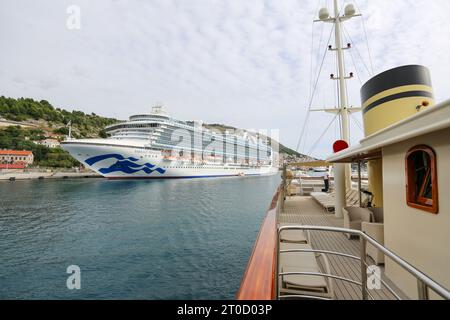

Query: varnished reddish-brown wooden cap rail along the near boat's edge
[[236, 187, 281, 301]]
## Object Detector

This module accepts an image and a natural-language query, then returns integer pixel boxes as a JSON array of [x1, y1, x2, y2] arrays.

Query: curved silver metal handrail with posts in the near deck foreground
[[276, 225, 450, 300]]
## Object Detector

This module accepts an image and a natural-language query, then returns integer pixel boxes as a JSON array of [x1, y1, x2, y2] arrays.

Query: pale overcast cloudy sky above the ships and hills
[[0, 0, 450, 157]]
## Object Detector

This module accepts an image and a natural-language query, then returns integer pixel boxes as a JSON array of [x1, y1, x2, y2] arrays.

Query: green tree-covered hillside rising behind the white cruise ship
[[0, 96, 306, 168]]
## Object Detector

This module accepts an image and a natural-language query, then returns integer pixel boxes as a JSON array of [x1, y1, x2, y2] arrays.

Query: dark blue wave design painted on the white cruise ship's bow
[[85, 154, 166, 174]]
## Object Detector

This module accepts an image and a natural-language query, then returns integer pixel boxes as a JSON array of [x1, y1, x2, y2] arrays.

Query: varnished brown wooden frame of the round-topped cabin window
[[405, 145, 439, 214]]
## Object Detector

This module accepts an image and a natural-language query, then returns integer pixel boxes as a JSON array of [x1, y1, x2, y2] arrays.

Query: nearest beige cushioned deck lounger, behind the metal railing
[[279, 243, 334, 299]]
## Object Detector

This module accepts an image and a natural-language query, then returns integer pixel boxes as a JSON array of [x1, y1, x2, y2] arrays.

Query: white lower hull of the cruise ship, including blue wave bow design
[[62, 139, 278, 179]]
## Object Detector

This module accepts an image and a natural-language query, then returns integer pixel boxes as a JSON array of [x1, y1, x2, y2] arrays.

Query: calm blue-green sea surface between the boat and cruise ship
[[0, 176, 280, 299]]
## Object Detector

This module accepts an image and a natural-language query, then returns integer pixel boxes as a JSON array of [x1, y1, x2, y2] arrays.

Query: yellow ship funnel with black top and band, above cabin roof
[[361, 65, 434, 136]]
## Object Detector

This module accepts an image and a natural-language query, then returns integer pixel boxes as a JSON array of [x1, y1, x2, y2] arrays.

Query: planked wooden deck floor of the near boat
[[277, 196, 406, 300]]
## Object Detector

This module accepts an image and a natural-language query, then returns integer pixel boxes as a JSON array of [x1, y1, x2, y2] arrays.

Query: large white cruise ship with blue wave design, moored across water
[[62, 105, 278, 179]]
